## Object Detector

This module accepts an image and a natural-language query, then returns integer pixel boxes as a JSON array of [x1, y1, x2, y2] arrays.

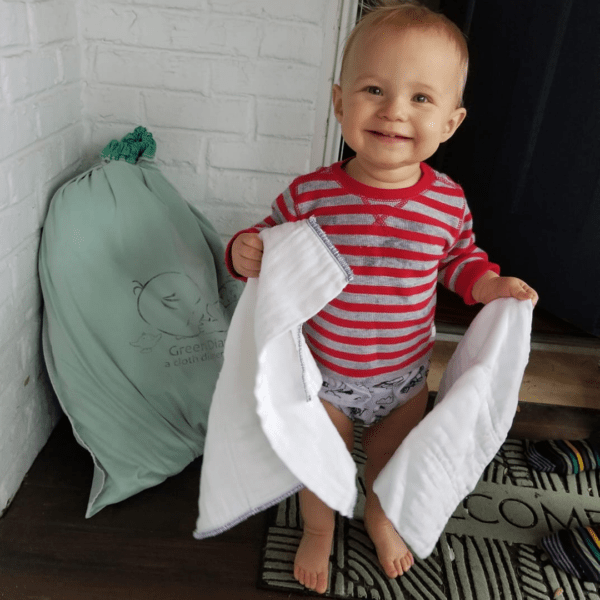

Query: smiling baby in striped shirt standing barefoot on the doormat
[[227, 2, 537, 593]]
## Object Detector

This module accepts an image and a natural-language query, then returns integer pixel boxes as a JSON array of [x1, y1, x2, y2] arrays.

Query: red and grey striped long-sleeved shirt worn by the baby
[[227, 162, 500, 385]]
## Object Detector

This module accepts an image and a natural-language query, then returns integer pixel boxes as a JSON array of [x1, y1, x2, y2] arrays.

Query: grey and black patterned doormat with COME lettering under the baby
[[259, 431, 600, 600]]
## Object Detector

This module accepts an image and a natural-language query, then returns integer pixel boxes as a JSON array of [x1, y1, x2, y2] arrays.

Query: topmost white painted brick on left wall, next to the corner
[[29, 0, 77, 44]]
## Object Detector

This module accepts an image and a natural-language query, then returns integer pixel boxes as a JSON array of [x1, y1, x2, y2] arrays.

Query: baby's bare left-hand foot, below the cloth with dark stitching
[[294, 529, 333, 594]]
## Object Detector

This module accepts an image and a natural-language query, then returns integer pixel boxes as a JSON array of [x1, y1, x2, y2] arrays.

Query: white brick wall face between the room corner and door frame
[[80, 0, 330, 238]]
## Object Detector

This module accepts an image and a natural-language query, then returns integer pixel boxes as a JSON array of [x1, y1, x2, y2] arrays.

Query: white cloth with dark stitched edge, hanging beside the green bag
[[194, 219, 357, 539]]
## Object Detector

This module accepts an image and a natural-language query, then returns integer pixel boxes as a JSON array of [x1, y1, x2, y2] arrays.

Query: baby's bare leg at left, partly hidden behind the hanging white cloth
[[294, 402, 354, 594]]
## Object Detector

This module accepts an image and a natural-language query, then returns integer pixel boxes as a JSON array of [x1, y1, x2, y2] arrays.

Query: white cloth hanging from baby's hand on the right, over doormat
[[373, 298, 533, 558]]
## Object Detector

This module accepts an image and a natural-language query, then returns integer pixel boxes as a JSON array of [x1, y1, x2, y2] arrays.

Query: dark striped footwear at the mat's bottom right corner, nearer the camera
[[541, 526, 600, 583]]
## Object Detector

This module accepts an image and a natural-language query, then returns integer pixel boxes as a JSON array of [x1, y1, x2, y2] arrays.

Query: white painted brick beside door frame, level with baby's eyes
[[212, 60, 319, 101]]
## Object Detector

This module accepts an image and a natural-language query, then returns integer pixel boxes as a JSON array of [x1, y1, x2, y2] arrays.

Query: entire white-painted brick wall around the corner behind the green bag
[[0, 0, 352, 513]]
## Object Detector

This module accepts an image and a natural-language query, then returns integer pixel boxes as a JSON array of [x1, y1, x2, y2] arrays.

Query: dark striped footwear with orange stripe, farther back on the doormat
[[526, 440, 600, 475]]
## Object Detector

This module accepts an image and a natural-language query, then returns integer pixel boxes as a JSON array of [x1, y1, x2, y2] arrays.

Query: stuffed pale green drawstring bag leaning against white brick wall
[[39, 127, 241, 517]]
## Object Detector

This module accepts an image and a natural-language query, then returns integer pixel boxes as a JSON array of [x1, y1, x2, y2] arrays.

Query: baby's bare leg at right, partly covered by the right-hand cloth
[[363, 386, 428, 578]]
